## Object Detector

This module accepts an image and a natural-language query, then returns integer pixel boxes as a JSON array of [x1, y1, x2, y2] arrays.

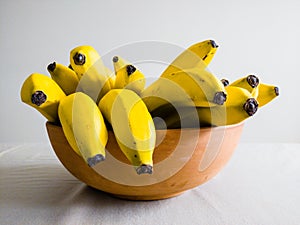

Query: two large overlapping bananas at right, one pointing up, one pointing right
[[141, 40, 226, 112]]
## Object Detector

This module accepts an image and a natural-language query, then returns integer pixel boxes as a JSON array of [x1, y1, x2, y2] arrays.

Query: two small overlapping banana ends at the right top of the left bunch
[[113, 56, 146, 94]]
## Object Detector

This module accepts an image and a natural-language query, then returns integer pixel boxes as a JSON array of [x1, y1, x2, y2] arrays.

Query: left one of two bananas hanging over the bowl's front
[[58, 92, 108, 166]]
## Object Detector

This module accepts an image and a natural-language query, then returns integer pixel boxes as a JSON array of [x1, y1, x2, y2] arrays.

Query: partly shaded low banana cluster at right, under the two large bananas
[[156, 74, 279, 129]]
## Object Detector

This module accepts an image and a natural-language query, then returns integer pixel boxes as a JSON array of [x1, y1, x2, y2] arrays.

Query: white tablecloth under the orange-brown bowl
[[0, 143, 300, 225]]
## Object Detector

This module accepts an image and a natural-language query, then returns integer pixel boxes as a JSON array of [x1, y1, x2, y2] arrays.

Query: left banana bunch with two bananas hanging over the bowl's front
[[21, 46, 156, 174]]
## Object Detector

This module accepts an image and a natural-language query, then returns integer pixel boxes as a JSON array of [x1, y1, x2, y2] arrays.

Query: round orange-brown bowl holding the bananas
[[46, 122, 244, 200]]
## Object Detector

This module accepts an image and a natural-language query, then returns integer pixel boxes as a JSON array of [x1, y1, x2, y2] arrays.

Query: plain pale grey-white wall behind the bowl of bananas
[[0, 0, 300, 142]]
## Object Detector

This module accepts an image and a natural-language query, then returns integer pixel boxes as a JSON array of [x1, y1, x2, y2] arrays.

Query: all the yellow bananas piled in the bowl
[[21, 40, 279, 174]]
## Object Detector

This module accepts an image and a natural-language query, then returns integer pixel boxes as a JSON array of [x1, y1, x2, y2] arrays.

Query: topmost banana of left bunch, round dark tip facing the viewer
[[70, 45, 111, 103]]
